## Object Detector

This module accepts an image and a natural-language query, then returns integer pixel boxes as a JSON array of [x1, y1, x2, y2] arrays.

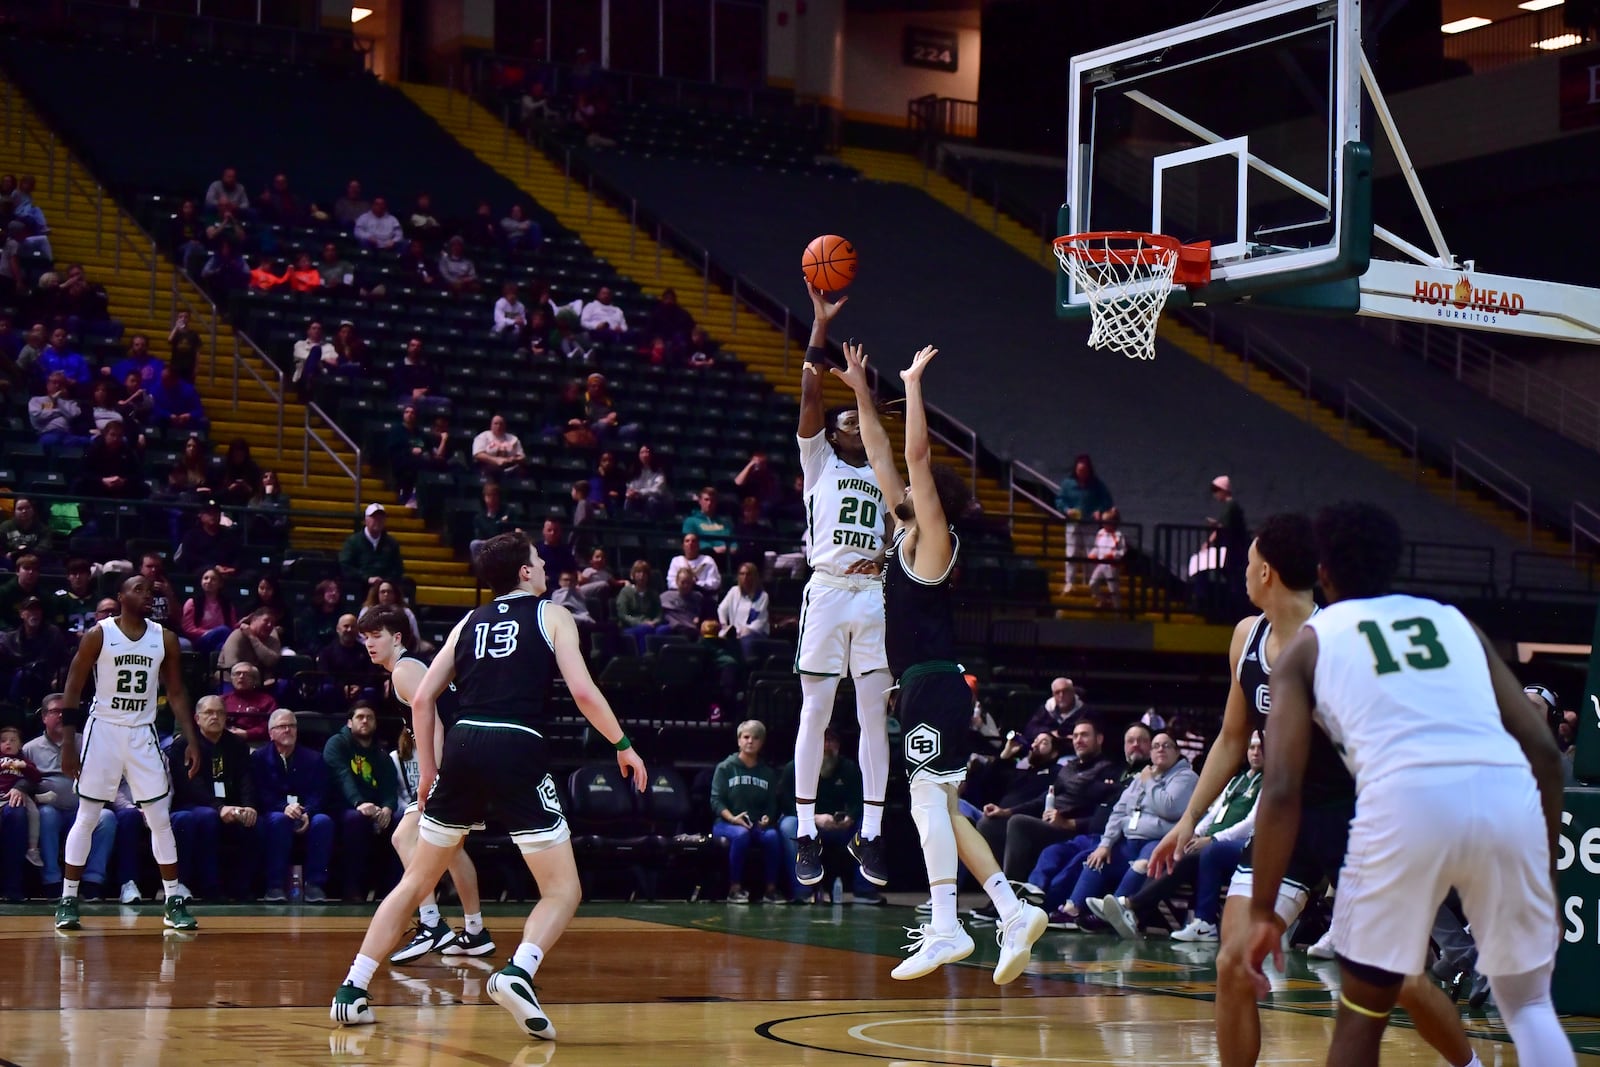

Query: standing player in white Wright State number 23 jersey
[[56, 574, 200, 929]]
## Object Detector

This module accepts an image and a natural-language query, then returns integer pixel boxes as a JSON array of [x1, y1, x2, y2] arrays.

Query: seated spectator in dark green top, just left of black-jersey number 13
[[322, 701, 400, 901]]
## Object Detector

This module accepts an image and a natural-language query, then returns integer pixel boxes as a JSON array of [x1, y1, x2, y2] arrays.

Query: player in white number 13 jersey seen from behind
[[1250, 504, 1576, 1067]]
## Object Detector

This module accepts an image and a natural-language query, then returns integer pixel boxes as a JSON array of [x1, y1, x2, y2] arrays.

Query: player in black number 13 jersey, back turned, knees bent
[[328, 533, 646, 1041]]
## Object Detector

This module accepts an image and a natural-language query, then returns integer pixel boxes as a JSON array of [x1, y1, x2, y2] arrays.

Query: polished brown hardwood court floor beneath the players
[[0, 904, 1600, 1067]]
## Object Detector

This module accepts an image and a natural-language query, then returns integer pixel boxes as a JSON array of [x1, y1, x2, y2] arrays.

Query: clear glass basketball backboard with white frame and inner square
[[1058, 0, 1371, 315]]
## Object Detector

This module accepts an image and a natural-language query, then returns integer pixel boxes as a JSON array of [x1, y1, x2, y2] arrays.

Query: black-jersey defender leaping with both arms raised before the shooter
[[834, 344, 1048, 985]]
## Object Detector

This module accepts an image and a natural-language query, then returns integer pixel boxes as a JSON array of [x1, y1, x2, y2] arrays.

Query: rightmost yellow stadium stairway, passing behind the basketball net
[[838, 147, 1568, 553]]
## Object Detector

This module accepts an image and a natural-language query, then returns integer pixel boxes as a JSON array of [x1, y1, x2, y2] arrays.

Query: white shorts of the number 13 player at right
[[1333, 766, 1560, 977]]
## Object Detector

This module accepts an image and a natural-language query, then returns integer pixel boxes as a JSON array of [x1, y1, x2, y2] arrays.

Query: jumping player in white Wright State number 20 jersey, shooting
[[795, 285, 898, 886]]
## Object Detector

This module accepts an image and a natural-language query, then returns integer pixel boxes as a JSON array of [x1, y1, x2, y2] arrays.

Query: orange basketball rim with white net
[[1054, 230, 1211, 360]]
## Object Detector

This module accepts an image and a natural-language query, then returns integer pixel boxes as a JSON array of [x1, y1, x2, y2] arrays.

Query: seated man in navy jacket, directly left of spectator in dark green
[[251, 709, 333, 904]]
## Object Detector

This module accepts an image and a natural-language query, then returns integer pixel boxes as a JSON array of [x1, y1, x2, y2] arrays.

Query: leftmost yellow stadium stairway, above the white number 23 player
[[0, 78, 477, 606]]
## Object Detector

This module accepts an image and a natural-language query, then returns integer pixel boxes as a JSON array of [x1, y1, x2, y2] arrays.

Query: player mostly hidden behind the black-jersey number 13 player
[[357, 605, 494, 963]]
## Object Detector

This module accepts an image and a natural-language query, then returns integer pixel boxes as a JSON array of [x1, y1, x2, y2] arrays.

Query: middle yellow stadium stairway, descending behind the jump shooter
[[400, 83, 1177, 617]]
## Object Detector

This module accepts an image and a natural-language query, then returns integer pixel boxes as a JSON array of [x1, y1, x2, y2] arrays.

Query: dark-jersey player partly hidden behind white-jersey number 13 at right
[[1149, 514, 1472, 1067]]
